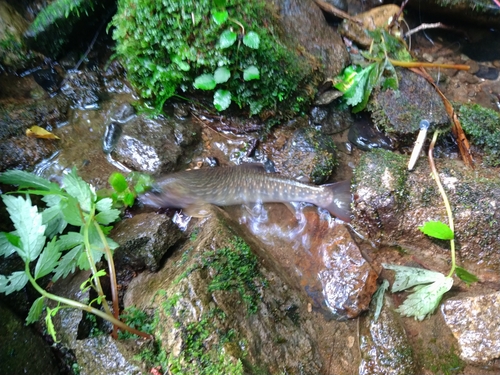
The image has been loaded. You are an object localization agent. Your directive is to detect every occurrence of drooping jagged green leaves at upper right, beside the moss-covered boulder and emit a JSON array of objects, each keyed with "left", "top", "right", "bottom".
[{"left": 334, "top": 29, "right": 411, "bottom": 113}]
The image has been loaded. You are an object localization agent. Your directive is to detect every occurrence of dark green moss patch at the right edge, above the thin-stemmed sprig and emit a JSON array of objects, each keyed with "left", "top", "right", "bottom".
[{"left": 458, "top": 104, "right": 500, "bottom": 167}]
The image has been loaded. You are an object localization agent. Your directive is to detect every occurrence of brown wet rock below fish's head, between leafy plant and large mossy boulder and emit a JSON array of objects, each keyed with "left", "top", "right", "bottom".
[{"left": 111, "top": 213, "right": 182, "bottom": 272}]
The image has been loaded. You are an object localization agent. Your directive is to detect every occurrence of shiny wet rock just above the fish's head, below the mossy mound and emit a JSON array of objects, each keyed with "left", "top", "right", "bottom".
[{"left": 112, "top": 115, "right": 200, "bottom": 173}]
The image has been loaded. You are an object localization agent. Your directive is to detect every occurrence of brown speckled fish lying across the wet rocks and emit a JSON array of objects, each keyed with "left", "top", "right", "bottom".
[{"left": 139, "top": 164, "right": 352, "bottom": 222}]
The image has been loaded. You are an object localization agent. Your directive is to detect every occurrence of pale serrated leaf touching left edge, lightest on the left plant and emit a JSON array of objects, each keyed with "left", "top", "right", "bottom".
[{"left": 2, "top": 195, "right": 45, "bottom": 262}]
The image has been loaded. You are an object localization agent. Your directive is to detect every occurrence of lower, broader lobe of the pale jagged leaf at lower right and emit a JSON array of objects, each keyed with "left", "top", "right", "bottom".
[{"left": 397, "top": 274, "right": 453, "bottom": 320}]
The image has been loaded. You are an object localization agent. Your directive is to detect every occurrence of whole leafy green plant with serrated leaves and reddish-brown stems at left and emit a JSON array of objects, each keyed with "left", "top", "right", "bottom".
[{"left": 0, "top": 169, "right": 149, "bottom": 341}]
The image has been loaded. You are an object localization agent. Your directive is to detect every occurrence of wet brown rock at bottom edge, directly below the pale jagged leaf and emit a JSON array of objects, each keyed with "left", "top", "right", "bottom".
[{"left": 359, "top": 298, "right": 416, "bottom": 375}]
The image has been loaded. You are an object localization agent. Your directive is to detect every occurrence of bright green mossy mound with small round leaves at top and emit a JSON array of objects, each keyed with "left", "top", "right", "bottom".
[{"left": 111, "top": 0, "right": 313, "bottom": 114}]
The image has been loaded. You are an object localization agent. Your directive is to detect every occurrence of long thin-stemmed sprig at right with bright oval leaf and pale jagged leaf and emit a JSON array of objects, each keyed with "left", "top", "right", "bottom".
[{"left": 383, "top": 131, "right": 478, "bottom": 320}]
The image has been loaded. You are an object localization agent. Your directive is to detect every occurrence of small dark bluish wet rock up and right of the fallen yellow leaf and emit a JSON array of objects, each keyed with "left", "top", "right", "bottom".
[{"left": 61, "top": 71, "right": 102, "bottom": 109}]
